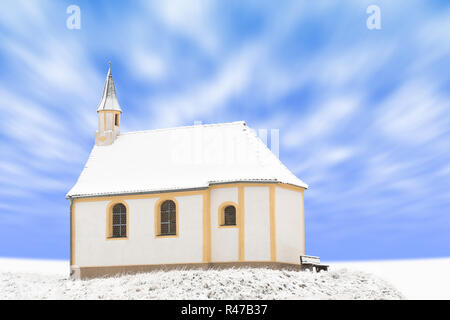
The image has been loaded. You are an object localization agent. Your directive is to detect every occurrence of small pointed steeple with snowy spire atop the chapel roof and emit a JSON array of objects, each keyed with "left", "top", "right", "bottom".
[{"left": 95, "top": 62, "right": 122, "bottom": 146}]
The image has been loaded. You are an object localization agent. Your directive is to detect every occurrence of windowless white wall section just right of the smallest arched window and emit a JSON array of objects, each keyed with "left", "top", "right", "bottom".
[{"left": 244, "top": 186, "right": 270, "bottom": 261}]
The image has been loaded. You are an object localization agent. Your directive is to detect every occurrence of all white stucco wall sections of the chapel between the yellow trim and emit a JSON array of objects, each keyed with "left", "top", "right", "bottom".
[{"left": 74, "top": 186, "right": 304, "bottom": 267}]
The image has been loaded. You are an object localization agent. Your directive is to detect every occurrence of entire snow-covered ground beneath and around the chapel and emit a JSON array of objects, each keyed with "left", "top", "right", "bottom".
[{"left": 0, "top": 258, "right": 450, "bottom": 299}]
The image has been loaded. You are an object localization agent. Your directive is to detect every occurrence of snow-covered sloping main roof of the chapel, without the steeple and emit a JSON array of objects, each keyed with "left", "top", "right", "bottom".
[{"left": 67, "top": 121, "right": 308, "bottom": 197}]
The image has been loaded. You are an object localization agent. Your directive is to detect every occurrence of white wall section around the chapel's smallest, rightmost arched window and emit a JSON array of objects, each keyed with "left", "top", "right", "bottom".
[{"left": 210, "top": 187, "right": 239, "bottom": 262}]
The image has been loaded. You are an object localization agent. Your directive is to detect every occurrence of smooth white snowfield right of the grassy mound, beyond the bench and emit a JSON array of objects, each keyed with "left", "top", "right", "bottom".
[{"left": 328, "top": 258, "right": 450, "bottom": 300}]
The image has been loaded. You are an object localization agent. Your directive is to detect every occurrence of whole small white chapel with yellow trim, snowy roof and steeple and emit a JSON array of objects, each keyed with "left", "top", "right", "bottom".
[{"left": 66, "top": 66, "right": 308, "bottom": 278}]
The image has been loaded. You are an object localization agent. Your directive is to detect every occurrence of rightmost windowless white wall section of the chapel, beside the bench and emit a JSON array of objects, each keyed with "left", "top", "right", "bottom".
[{"left": 275, "top": 187, "right": 304, "bottom": 263}]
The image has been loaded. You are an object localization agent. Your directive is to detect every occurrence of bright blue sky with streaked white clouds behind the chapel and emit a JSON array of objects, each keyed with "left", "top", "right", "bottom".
[{"left": 0, "top": 0, "right": 450, "bottom": 260}]
